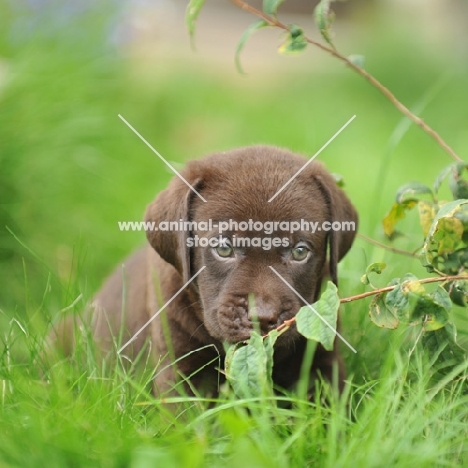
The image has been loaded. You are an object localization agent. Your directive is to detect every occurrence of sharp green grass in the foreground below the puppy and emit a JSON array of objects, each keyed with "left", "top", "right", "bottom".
[{"left": 0, "top": 324, "right": 468, "bottom": 467}]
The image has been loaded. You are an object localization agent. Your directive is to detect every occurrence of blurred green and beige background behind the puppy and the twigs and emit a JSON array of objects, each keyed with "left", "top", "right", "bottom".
[{"left": 0, "top": 0, "right": 468, "bottom": 369}]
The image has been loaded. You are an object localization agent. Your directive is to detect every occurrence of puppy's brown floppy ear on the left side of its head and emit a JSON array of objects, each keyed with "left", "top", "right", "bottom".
[{"left": 145, "top": 177, "right": 203, "bottom": 284}]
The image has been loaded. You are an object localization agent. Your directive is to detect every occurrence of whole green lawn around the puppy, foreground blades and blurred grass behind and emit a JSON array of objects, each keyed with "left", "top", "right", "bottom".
[{"left": 0, "top": 2, "right": 468, "bottom": 468}]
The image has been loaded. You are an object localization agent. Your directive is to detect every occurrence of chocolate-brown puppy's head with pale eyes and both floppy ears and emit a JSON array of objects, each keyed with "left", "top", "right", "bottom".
[{"left": 146, "top": 146, "right": 357, "bottom": 342}]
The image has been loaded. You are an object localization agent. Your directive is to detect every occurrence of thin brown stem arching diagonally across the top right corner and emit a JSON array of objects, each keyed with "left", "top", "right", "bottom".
[{"left": 230, "top": 0, "right": 462, "bottom": 161}]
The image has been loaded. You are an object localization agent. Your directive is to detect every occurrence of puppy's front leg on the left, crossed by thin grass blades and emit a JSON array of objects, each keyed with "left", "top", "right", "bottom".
[{"left": 147, "top": 251, "right": 223, "bottom": 396}]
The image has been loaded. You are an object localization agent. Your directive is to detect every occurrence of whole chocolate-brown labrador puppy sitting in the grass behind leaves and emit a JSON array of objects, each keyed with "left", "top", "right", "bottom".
[{"left": 67, "top": 146, "right": 357, "bottom": 395}]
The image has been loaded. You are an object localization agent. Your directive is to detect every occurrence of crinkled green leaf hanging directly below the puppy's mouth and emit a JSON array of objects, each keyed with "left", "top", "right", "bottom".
[{"left": 225, "top": 332, "right": 270, "bottom": 398}]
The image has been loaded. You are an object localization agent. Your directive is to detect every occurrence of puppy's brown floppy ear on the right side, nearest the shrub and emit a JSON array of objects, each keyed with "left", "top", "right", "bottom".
[{"left": 315, "top": 172, "right": 358, "bottom": 285}]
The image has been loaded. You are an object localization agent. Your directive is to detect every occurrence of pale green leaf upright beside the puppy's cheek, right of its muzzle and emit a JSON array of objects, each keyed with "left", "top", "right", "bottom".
[{"left": 296, "top": 281, "right": 340, "bottom": 351}]
